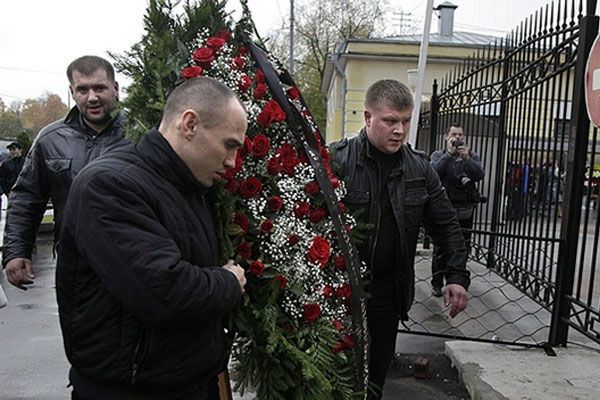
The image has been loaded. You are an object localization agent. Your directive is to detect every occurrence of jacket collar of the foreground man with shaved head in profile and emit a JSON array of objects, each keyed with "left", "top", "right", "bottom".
[{"left": 137, "top": 128, "right": 207, "bottom": 194}]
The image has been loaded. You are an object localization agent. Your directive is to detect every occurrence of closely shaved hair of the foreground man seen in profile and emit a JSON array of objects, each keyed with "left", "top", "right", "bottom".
[{"left": 162, "top": 76, "right": 246, "bottom": 129}]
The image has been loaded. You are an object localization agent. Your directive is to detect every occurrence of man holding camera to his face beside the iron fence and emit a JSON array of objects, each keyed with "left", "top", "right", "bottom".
[{"left": 431, "top": 123, "right": 485, "bottom": 297}]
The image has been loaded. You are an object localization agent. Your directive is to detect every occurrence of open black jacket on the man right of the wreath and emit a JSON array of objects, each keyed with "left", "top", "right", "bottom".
[{"left": 331, "top": 129, "right": 469, "bottom": 320}]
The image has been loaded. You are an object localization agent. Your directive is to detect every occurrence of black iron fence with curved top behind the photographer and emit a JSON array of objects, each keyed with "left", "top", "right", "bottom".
[{"left": 407, "top": 0, "right": 600, "bottom": 345}]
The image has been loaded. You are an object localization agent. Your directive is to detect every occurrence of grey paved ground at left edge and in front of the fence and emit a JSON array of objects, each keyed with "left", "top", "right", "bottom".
[{"left": 0, "top": 235, "right": 600, "bottom": 400}]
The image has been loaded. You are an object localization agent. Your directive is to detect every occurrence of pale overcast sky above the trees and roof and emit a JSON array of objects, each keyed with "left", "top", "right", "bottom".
[{"left": 0, "top": 0, "right": 568, "bottom": 104}]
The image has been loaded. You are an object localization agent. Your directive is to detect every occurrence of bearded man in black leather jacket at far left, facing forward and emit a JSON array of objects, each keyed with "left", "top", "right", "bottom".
[{"left": 2, "top": 56, "right": 128, "bottom": 290}]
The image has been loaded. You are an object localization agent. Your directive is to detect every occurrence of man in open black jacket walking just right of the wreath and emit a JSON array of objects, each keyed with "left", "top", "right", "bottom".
[{"left": 332, "top": 79, "right": 469, "bottom": 399}]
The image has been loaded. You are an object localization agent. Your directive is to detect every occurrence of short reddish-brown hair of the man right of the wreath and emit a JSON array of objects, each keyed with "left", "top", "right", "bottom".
[{"left": 365, "top": 79, "right": 414, "bottom": 111}]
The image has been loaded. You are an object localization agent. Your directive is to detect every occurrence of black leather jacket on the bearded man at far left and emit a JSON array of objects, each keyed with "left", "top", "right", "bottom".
[{"left": 2, "top": 107, "right": 127, "bottom": 265}]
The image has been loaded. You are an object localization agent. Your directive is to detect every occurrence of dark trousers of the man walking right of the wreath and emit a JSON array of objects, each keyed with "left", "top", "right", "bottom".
[{"left": 367, "top": 295, "right": 399, "bottom": 400}]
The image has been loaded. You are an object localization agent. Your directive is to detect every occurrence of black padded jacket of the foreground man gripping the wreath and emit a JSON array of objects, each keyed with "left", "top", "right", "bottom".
[{"left": 56, "top": 130, "right": 241, "bottom": 399}]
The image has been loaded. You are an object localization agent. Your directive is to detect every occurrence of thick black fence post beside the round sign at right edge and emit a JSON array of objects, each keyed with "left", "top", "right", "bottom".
[{"left": 548, "top": 0, "right": 599, "bottom": 346}]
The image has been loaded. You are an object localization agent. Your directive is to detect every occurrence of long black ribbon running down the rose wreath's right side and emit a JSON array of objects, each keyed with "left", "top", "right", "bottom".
[{"left": 243, "top": 34, "right": 369, "bottom": 396}]
